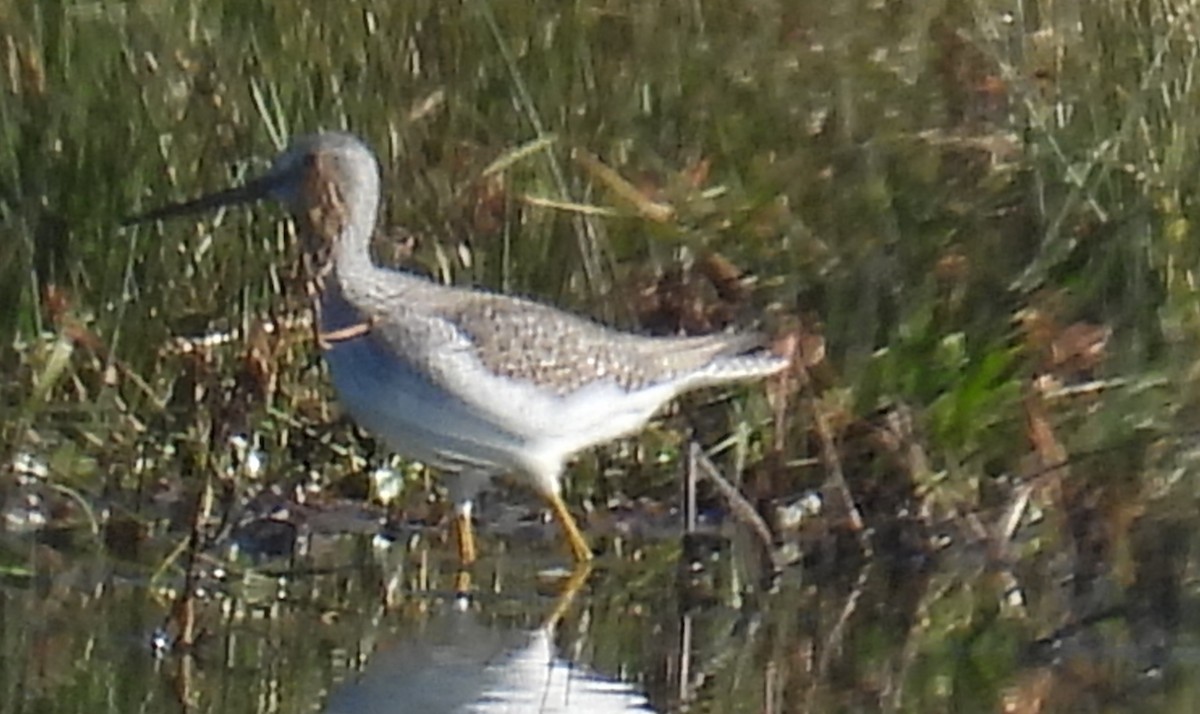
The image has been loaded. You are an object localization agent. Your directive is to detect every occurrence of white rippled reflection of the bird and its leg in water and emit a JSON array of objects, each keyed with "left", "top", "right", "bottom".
[{"left": 325, "top": 572, "right": 653, "bottom": 714}]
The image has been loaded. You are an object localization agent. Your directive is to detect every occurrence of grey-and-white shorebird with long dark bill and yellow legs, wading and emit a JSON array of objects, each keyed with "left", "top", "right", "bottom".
[{"left": 127, "top": 132, "right": 787, "bottom": 564}]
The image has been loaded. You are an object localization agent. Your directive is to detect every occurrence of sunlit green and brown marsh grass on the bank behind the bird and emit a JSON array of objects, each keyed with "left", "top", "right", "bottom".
[{"left": 0, "top": 0, "right": 1200, "bottom": 710}]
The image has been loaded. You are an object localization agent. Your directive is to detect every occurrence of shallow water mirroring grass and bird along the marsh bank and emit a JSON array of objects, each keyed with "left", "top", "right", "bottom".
[{"left": 0, "top": 504, "right": 1200, "bottom": 712}]
